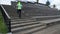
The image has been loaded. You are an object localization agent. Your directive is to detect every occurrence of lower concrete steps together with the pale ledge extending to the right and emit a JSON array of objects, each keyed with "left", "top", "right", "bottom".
[{"left": 11, "top": 18, "right": 60, "bottom": 34}]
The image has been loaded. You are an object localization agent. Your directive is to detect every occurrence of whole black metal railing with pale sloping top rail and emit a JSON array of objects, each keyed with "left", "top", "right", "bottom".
[{"left": 0, "top": 5, "right": 11, "bottom": 33}]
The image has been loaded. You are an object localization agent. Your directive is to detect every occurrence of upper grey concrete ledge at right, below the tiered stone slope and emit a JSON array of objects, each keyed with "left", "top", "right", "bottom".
[{"left": 32, "top": 15, "right": 60, "bottom": 21}]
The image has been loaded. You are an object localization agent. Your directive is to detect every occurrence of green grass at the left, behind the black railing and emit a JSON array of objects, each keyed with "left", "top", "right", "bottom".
[{"left": 0, "top": 10, "right": 7, "bottom": 34}]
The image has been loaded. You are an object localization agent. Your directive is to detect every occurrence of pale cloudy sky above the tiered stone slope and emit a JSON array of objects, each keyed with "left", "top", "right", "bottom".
[{"left": 0, "top": 0, "right": 60, "bottom": 9}]
